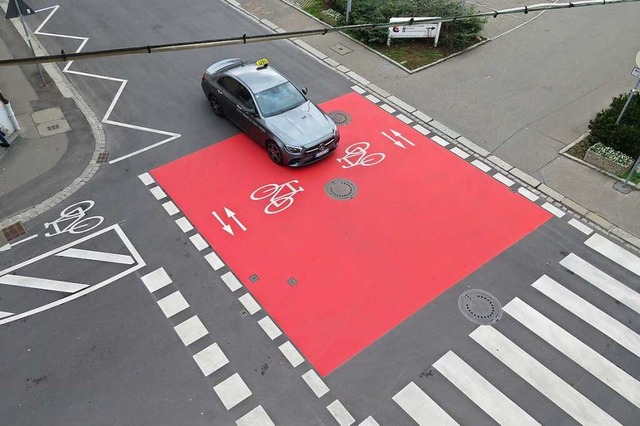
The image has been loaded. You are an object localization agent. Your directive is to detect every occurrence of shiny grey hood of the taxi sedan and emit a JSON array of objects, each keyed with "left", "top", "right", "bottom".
[{"left": 266, "top": 101, "right": 335, "bottom": 146}]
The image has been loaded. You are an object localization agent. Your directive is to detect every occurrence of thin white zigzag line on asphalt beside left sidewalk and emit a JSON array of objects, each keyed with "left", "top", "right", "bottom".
[{"left": 33, "top": 5, "right": 182, "bottom": 164}]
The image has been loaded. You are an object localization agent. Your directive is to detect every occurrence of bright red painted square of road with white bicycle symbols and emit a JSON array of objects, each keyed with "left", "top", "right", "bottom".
[{"left": 152, "top": 93, "right": 550, "bottom": 376}]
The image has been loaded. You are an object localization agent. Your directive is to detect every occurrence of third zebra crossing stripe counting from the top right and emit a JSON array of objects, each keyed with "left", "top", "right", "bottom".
[{"left": 533, "top": 275, "right": 640, "bottom": 356}]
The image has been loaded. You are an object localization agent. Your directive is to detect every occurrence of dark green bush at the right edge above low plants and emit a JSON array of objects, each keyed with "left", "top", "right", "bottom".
[{"left": 589, "top": 94, "right": 640, "bottom": 158}]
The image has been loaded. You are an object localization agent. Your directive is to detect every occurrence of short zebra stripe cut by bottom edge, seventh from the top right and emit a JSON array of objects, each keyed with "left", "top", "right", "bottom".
[{"left": 393, "top": 382, "right": 458, "bottom": 426}]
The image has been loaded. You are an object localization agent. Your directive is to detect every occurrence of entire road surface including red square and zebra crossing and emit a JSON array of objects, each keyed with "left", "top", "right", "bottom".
[{"left": 0, "top": 0, "right": 640, "bottom": 426}]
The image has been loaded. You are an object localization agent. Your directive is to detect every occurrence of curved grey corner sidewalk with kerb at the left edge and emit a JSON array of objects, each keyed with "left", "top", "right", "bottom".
[{"left": 0, "top": 12, "right": 104, "bottom": 240}]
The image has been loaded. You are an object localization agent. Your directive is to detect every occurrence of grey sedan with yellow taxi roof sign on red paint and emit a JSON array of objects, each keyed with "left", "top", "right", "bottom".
[{"left": 202, "top": 58, "right": 340, "bottom": 167}]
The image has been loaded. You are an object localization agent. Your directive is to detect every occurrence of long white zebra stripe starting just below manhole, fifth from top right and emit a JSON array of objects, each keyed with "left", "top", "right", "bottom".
[{"left": 469, "top": 325, "right": 620, "bottom": 426}]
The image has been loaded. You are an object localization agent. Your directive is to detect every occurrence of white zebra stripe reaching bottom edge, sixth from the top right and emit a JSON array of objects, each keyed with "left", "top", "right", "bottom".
[{"left": 433, "top": 351, "right": 540, "bottom": 426}]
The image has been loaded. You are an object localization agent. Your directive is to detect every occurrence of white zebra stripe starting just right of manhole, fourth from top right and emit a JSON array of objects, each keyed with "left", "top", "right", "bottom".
[{"left": 503, "top": 297, "right": 640, "bottom": 407}]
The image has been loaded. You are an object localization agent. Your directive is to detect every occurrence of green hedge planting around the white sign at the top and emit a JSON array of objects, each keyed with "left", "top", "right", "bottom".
[{"left": 325, "top": 0, "right": 485, "bottom": 50}]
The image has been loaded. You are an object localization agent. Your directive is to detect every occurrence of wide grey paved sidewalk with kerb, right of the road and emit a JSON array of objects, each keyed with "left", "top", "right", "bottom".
[{"left": 227, "top": 0, "right": 640, "bottom": 248}]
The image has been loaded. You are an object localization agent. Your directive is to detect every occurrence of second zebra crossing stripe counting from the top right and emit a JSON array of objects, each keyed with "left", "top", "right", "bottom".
[{"left": 560, "top": 253, "right": 640, "bottom": 314}]
